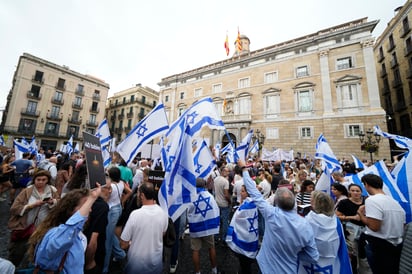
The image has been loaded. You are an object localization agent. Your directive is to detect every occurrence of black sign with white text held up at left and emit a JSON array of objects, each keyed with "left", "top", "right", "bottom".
[{"left": 83, "top": 132, "right": 106, "bottom": 189}]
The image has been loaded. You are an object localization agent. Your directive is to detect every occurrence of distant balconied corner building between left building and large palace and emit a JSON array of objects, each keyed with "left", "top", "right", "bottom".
[{"left": 106, "top": 84, "right": 159, "bottom": 141}]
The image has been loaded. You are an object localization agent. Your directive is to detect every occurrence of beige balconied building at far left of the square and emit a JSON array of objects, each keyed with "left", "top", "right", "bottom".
[{"left": 0, "top": 53, "right": 109, "bottom": 150}]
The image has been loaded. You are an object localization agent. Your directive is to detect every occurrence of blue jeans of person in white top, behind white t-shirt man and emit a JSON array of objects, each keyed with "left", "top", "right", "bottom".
[{"left": 103, "top": 204, "right": 126, "bottom": 273}]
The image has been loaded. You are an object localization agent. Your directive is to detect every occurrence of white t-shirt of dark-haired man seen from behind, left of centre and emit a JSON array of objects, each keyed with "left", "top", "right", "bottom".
[{"left": 120, "top": 205, "right": 169, "bottom": 273}]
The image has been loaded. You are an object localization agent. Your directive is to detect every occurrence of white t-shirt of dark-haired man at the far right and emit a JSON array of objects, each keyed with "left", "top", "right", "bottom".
[{"left": 365, "top": 194, "right": 405, "bottom": 244}]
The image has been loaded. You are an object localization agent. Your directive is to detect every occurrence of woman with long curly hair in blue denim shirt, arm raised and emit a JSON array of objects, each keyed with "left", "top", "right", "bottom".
[{"left": 29, "top": 184, "right": 101, "bottom": 273}]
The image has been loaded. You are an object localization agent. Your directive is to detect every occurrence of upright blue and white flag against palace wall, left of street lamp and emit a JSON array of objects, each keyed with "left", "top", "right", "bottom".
[{"left": 315, "top": 134, "right": 342, "bottom": 195}]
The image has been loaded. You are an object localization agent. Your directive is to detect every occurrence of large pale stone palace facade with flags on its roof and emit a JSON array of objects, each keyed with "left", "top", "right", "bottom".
[{"left": 159, "top": 18, "right": 390, "bottom": 159}]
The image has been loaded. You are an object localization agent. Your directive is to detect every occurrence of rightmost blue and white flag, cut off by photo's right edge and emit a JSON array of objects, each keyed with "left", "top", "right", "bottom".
[{"left": 374, "top": 126, "right": 412, "bottom": 223}]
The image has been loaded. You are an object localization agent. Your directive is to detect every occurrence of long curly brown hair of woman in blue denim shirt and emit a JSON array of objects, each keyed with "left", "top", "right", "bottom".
[{"left": 28, "top": 188, "right": 89, "bottom": 262}]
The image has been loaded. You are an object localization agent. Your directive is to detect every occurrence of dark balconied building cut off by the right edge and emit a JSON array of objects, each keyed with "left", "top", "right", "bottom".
[{"left": 374, "top": 1, "right": 412, "bottom": 141}]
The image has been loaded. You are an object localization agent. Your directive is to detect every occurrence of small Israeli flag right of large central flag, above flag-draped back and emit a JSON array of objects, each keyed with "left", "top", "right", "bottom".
[{"left": 193, "top": 140, "right": 216, "bottom": 179}]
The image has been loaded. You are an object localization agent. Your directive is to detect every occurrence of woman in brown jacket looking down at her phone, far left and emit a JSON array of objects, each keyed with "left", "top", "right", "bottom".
[{"left": 8, "top": 170, "right": 58, "bottom": 267}]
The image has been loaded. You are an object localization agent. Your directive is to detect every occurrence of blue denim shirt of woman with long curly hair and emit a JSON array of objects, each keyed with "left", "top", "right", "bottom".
[{"left": 35, "top": 211, "right": 87, "bottom": 273}]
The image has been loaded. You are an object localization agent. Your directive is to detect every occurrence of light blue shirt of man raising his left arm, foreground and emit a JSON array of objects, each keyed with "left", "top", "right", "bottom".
[{"left": 243, "top": 171, "right": 319, "bottom": 274}]
